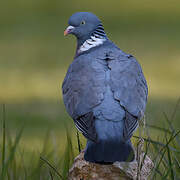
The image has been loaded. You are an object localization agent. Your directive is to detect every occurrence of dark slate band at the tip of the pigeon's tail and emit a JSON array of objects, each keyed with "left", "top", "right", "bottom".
[{"left": 84, "top": 140, "right": 135, "bottom": 164}]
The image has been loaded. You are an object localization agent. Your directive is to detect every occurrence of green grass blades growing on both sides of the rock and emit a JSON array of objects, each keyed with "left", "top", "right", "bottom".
[{"left": 0, "top": 101, "right": 180, "bottom": 180}]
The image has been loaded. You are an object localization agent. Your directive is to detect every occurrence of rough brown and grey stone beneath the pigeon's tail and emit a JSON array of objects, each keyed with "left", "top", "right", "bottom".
[{"left": 68, "top": 152, "right": 154, "bottom": 180}]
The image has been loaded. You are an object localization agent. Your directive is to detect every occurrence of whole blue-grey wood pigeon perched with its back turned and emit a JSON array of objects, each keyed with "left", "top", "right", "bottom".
[{"left": 62, "top": 12, "right": 148, "bottom": 164}]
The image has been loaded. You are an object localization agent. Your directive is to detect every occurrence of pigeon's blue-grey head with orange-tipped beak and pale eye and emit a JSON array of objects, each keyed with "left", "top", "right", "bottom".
[{"left": 64, "top": 12, "right": 106, "bottom": 43}]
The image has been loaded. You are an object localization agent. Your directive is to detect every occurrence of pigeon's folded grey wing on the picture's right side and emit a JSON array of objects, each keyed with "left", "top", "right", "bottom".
[{"left": 109, "top": 54, "right": 148, "bottom": 139}]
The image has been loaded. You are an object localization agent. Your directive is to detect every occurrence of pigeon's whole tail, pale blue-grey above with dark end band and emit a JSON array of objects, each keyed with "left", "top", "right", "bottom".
[{"left": 84, "top": 119, "right": 135, "bottom": 164}]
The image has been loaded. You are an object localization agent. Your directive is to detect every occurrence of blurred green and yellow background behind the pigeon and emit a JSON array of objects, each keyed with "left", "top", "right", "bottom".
[{"left": 0, "top": 0, "right": 180, "bottom": 158}]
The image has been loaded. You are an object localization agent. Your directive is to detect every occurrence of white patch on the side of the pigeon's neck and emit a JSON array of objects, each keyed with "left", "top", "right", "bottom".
[{"left": 78, "top": 36, "right": 106, "bottom": 53}]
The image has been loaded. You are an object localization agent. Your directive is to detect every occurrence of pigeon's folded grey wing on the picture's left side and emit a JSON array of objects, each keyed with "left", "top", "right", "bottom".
[{"left": 62, "top": 55, "right": 105, "bottom": 141}]
